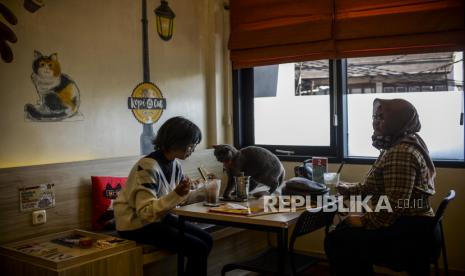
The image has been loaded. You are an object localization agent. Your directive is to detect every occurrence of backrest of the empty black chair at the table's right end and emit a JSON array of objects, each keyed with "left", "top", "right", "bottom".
[{"left": 289, "top": 203, "right": 337, "bottom": 252}]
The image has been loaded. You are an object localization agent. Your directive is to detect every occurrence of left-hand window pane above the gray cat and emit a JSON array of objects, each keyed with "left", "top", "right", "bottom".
[{"left": 234, "top": 60, "right": 335, "bottom": 156}]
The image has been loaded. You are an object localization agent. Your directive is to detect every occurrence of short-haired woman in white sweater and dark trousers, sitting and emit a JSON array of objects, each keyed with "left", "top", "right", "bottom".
[{"left": 113, "top": 117, "right": 213, "bottom": 275}]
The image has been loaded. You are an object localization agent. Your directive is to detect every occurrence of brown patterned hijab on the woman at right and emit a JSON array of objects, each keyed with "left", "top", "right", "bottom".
[{"left": 371, "top": 99, "right": 436, "bottom": 180}]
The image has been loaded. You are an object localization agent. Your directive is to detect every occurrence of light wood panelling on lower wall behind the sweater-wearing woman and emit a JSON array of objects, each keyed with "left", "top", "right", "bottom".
[{"left": 0, "top": 149, "right": 222, "bottom": 244}]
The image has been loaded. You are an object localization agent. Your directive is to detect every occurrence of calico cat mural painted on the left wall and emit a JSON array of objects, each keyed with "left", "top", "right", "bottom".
[{"left": 24, "top": 51, "right": 82, "bottom": 122}]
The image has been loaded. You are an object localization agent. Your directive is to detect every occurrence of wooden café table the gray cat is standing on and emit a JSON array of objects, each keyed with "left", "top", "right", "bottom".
[{"left": 172, "top": 200, "right": 304, "bottom": 275}]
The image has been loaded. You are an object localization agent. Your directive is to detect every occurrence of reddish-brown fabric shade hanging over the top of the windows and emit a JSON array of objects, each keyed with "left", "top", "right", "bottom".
[{"left": 229, "top": 0, "right": 465, "bottom": 68}]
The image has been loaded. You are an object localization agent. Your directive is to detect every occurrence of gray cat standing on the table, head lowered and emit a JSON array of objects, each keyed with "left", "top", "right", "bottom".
[{"left": 213, "top": 145, "right": 285, "bottom": 198}]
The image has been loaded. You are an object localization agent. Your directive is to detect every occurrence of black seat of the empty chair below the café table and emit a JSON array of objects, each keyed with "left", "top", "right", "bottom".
[{"left": 222, "top": 248, "right": 318, "bottom": 275}]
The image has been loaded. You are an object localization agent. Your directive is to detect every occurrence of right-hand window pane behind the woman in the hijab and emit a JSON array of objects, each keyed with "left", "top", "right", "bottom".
[{"left": 347, "top": 52, "right": 464, "bottom": 160}]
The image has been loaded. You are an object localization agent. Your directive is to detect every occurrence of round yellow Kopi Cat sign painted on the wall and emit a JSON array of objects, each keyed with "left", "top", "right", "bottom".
[{"left": 128, "top": 82, "right": 166, "bottom": 124}]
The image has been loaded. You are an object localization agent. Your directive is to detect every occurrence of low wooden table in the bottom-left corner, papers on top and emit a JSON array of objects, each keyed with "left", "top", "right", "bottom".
[{"left": 0, "top": 229, "right": 143, "bottom": 276}]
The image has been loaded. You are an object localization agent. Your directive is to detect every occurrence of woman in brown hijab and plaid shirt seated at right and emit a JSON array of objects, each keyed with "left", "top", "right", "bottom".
[{"left": 325, "top": 99, "right": 436, "bottom": 275}]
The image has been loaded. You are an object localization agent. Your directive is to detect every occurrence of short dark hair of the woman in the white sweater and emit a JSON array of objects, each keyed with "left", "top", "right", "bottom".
[{"left": 153, "top": 117, "right": 202, "bottom": 150}]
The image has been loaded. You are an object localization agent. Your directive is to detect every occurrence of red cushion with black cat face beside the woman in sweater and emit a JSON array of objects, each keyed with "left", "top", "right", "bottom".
[{"left": 91, "top": 176, "right": 127, "bottom": 230}]
